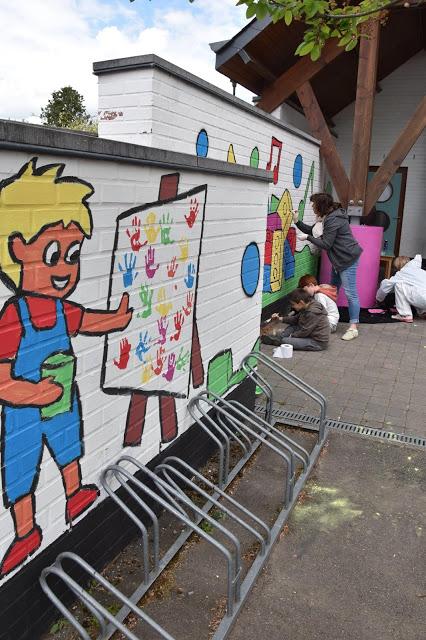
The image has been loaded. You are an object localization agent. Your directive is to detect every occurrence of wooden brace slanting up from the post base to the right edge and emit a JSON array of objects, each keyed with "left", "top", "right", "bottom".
[{"left": 364, "top": 97, "right": 426, "bottom": 215}]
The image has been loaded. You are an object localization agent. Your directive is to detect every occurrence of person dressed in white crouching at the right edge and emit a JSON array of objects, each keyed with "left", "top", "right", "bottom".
[{"left": 376, "top": 254, "right": 426, "bottom": 322}]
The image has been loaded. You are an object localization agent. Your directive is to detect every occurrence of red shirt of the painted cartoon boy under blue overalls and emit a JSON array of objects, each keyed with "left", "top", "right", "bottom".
[{"left": 0, "top": 295, "right": 84, "bottom": 362}]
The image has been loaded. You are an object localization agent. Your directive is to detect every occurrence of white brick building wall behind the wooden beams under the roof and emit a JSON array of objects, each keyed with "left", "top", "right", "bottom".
[{"left": 334, "top": 51, "right": 426, "bottom": 256}]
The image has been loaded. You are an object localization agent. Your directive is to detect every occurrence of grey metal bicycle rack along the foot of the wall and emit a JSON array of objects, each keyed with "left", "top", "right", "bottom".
[{"left": 40, "top": 352, "right": 327, "bottom": 640}]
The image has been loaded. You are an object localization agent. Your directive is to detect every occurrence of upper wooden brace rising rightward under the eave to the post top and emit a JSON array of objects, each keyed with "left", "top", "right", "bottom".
[{"left": 257, "top": 38, "right": 345, "bottom": 113}]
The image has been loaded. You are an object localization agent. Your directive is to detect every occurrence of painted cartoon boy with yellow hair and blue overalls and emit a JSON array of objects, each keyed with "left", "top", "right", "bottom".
[{"left": 0, "top": 158, "right": 132, "bottom": 578}]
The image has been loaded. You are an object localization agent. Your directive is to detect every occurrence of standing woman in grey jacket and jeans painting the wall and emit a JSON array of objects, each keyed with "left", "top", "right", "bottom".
[{"left": 293, "top": 193, "right": 362, "bottom": 340}]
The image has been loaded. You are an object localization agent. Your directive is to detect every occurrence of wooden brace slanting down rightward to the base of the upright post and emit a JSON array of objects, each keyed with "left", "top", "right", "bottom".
[{"left": 297, "top": 82, "right": 349, "bottom": 206}]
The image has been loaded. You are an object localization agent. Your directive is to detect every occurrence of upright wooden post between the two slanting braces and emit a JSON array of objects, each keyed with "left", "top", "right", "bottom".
[{"left": 349, "top": 20, "right": 380, "bottom": 210}]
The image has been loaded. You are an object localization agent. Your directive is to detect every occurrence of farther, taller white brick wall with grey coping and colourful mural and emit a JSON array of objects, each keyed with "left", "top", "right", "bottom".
[{"left": 95, "top": 56, "right": 322, "bottom": 307}]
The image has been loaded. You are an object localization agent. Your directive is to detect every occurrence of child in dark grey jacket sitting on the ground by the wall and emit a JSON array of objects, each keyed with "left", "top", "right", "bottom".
[{"left": 262, "top": 289, "right": 330, "bottom": 351}]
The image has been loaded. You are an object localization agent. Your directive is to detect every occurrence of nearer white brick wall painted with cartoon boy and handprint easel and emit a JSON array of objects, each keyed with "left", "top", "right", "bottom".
[{"left": 0, "top": 122, "right": 269, "bottom": 640}]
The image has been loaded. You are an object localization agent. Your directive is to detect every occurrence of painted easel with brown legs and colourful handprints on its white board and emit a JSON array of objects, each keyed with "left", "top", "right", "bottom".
[{"left": 101, "top": 174, "right": 207, "bottom": 446}]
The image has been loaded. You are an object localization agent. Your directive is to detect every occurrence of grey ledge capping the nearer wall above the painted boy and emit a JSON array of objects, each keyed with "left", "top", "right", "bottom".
[{"left": 0, "top": 120, "right": 272, "bottom": 182}]
